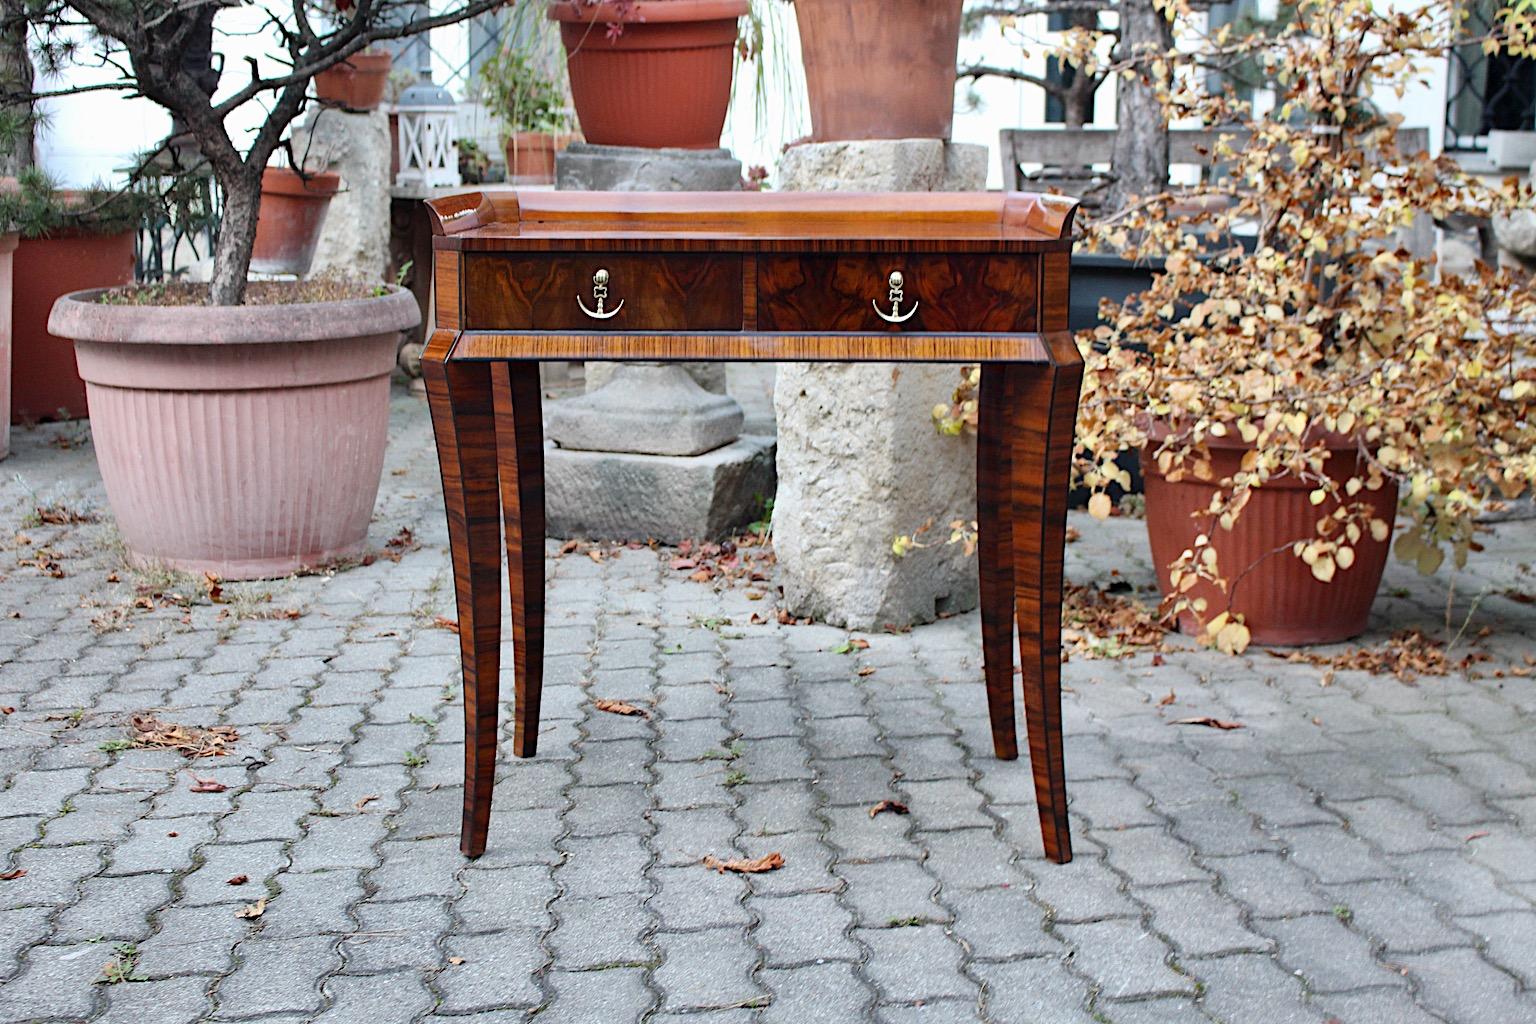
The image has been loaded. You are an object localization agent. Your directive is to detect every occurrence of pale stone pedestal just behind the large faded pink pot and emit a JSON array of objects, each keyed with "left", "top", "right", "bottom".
[{"left": 293, "top": 107, "right": 390, "bottom": 281}]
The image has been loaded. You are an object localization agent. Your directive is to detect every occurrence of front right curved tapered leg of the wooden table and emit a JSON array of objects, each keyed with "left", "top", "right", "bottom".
[{"left": 1014, "top": 335, "right": 1083, "bottom": 864}]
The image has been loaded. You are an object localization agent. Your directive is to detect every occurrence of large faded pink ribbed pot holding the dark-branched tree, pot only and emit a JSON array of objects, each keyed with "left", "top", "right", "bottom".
[{"left": 49, "top": 289, "right": 421, "bottom": 579}]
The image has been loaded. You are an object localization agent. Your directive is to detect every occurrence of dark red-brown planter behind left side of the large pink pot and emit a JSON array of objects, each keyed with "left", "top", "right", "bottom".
[{"left": 8, "top": 230, "right": 135, "bottom": 424}]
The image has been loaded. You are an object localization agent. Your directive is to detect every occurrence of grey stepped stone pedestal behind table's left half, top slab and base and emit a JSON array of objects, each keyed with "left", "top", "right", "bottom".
[{"left": 544, "top": 143, "right": 774, "bottom": 543}]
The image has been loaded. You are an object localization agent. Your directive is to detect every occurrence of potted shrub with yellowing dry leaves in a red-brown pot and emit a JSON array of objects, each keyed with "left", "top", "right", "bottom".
[{"left": 1077, "top": 0, "right": 1536, "bottom": 649}]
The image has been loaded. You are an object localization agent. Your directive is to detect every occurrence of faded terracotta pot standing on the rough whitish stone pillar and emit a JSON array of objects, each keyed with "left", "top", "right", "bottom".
[{"left": 794, "top": 0, "right": 963, "bottom": 143}]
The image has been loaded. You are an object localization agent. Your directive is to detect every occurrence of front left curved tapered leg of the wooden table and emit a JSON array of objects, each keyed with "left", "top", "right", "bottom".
[{"left": 421, "top": 336, "right": 501, "bottom": 857}]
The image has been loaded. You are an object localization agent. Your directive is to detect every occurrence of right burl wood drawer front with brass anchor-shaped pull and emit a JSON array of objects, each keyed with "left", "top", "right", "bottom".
[{"left": 757, "top": 253, "right": 1040, "bottom": 332}]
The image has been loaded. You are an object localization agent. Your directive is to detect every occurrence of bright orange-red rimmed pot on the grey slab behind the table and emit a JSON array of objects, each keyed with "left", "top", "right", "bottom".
[{"left": 548, "top": 0, "right": 746, "bottom": 149}]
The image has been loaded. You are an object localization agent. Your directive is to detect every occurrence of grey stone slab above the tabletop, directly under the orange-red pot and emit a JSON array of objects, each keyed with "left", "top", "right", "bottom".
[{"left": 554, "top": 143, "right": 742, "bottom": 192}]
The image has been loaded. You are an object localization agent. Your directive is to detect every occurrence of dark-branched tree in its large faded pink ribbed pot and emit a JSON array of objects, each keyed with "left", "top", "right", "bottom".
[{"left": 29, "top": 0, "right": 501, "bottom": 579}]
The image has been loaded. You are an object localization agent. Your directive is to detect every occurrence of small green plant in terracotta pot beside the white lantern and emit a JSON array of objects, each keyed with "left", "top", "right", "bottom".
[{"left": 475, "top": 46, "right": 570, "bottom": 184}]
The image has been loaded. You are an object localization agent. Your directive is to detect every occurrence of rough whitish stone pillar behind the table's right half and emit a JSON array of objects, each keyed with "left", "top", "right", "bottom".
[{"left": 773, "top": 138, "right": 986, "bottom": 629}]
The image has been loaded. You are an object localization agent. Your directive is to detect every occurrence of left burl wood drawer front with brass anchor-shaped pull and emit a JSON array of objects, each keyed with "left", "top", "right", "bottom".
[{"left": 464, "top": 253, "right": 742, "bottom": 332}]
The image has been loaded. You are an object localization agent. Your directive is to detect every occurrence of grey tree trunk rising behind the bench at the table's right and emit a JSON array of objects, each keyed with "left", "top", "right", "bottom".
[{"left": 1104, "top": 0, "right": 1174, "bottom": 213}]
